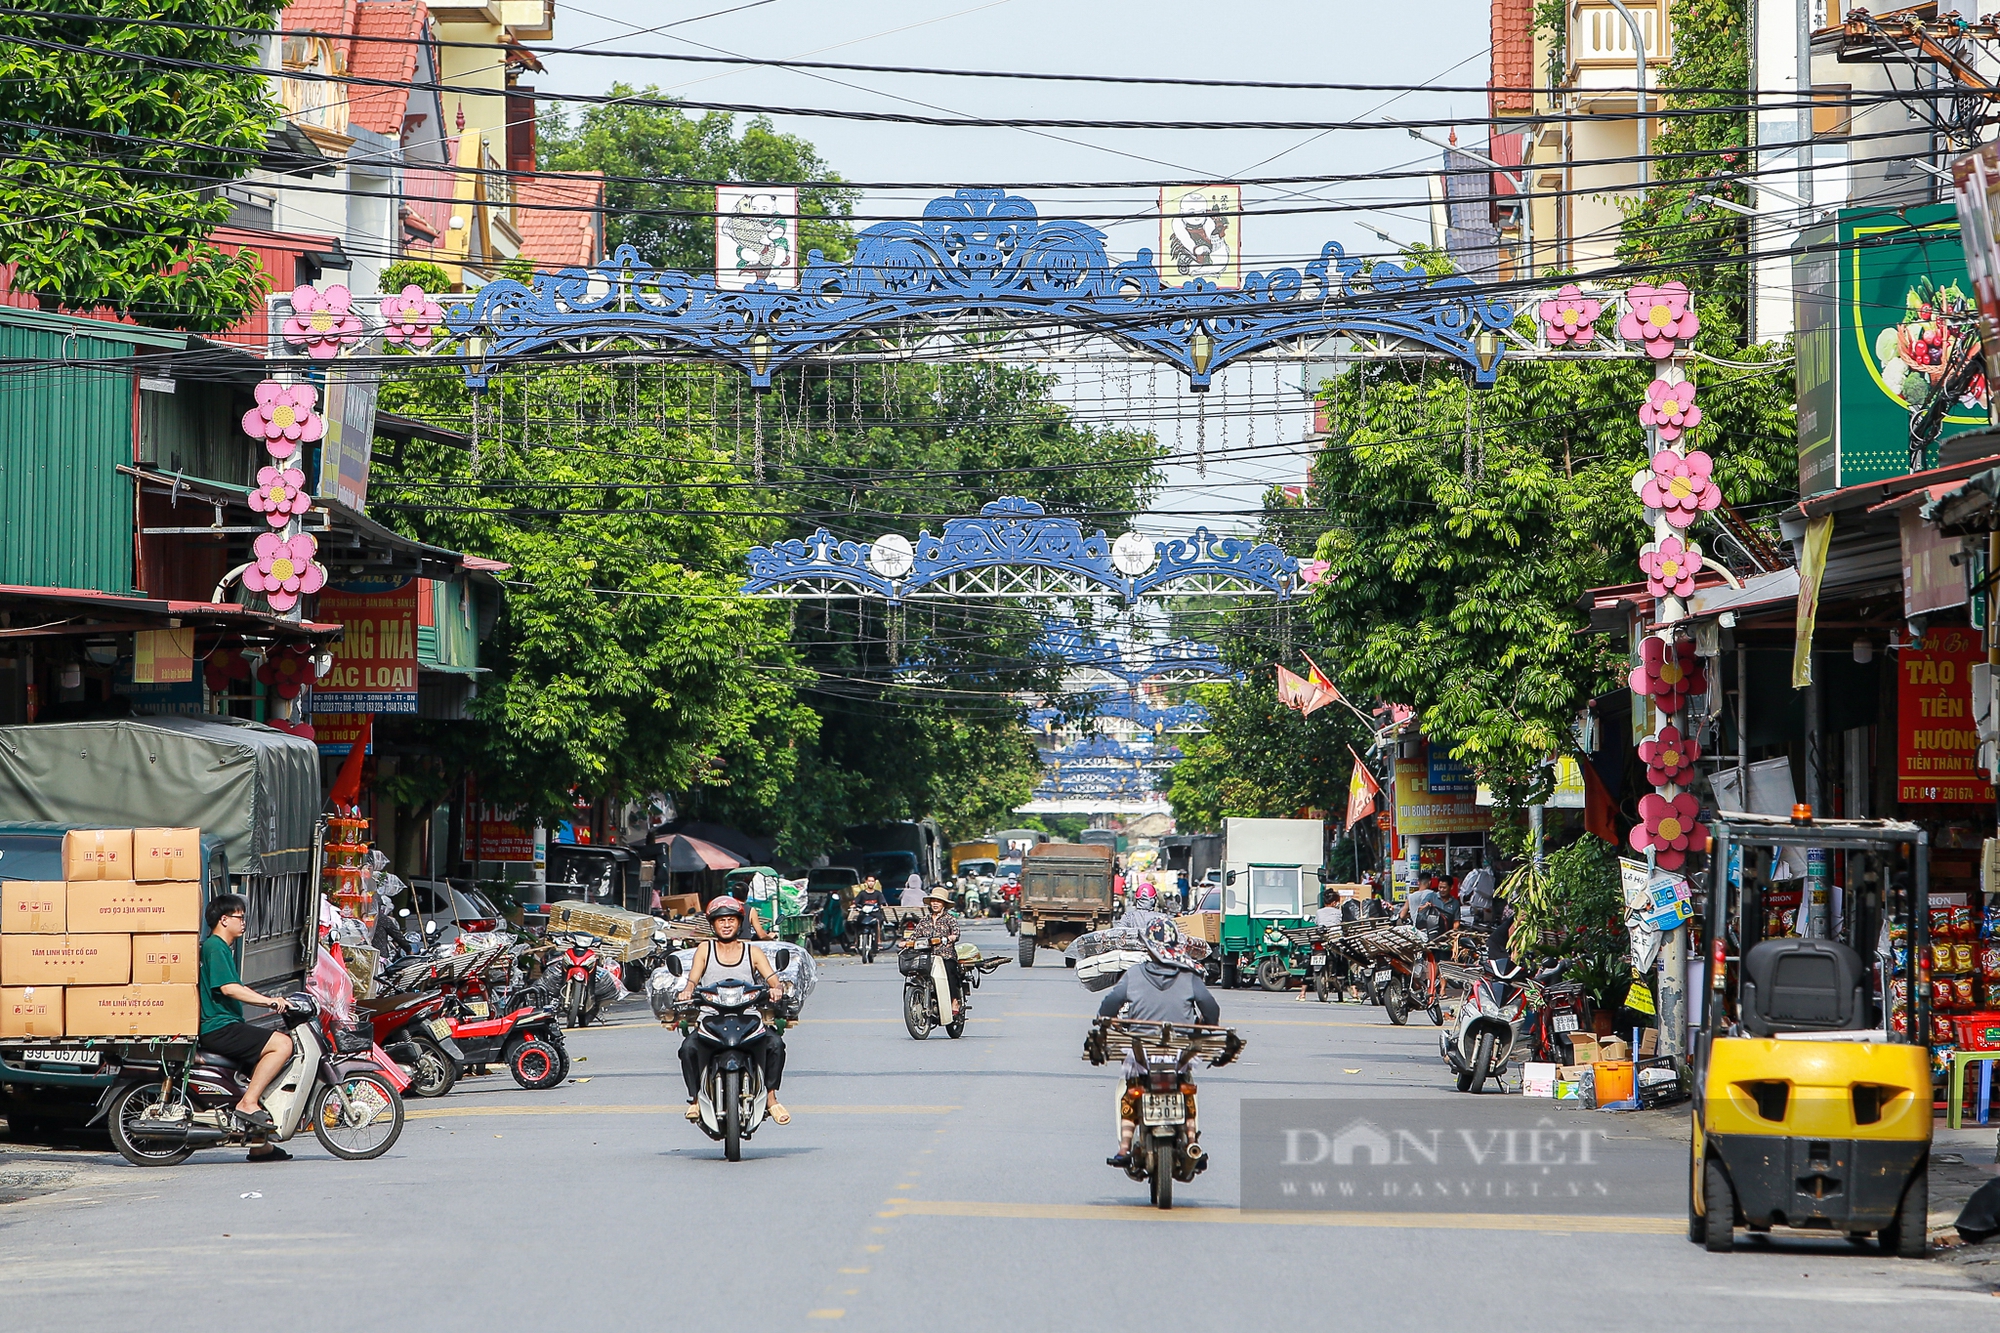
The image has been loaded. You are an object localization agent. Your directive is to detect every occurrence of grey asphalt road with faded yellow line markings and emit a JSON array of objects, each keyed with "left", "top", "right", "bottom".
[{"left": 0, "top": 912, "right": 2000, "bottom": 1333}]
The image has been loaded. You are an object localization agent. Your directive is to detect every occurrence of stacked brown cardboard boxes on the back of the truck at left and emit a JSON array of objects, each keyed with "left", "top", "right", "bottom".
[{"left": 0, "top": 829, "right": 202, "bottom": 1037}]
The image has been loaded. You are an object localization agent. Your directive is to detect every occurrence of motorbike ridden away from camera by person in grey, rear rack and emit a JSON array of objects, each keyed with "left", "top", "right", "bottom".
[{"left": 1084, "top": 1019, "right": 1244, "bottom": 1211}]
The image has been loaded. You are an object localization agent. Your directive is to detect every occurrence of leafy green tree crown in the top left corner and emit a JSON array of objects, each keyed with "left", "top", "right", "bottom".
[{"left": 0, "top": 0, "right": 284, "bottom": 332}]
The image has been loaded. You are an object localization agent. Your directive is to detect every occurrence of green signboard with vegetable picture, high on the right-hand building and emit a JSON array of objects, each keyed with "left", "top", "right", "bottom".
[{"left": 1792, "top": 204, "right": 1986, "bottom": 496}]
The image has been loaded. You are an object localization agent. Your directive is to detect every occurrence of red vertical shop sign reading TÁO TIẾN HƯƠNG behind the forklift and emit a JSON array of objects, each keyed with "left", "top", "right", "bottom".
[{"left": 1896, "top": 626, "right": 1994, "bottom": 805}]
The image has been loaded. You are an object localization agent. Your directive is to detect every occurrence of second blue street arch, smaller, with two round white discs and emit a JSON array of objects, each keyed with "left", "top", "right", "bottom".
[{"left": 742, "top": 496, "right": 1298, "bottom": 602}]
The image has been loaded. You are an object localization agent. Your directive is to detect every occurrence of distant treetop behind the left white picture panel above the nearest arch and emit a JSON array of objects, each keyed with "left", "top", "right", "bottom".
[{"left": 536, "top": 84, "right": 856, "bottom": 272}]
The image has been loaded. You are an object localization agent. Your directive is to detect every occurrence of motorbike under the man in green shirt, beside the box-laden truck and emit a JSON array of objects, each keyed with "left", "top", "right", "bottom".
[{"left": 100, "top": 993, "right": 404, "bottom": 1167}]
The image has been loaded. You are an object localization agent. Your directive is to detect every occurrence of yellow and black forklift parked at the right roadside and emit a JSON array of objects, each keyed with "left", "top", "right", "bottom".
[{"left": 1688, "top": 807, "right": 1932, "bottom": 1259}]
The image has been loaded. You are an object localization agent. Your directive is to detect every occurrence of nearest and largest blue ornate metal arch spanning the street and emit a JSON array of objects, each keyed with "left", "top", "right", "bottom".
[{"left": 444, "top": 190, "right": 1514, "bottom": 392}]
